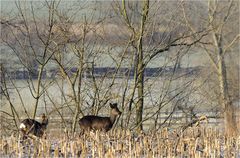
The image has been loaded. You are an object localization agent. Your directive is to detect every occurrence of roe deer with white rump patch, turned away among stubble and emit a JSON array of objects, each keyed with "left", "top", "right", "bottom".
[{"left": 20, "top": 114, "right": 48, "bottom": 138}]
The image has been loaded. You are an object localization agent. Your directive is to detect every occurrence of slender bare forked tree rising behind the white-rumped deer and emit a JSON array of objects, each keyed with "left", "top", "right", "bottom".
[{"left": 1, "top": 1, "right": 57, "bottom": 118}]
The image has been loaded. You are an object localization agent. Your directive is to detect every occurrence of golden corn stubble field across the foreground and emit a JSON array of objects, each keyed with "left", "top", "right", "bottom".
[{"left": 0, "top": 127, "right": 240, "bottom": 158}]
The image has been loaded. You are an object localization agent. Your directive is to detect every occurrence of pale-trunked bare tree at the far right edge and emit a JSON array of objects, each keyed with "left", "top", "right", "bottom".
[{"left": 183, "top": 1, "right": 240, "bottom": 136}]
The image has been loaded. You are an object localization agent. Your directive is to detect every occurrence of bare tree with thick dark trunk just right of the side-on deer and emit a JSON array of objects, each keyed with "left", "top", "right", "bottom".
[{"left": 116, "top": 0, "right": 206, "bottom": 131}]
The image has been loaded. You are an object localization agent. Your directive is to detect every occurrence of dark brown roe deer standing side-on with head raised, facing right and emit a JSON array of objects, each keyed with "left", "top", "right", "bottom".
[{"left": 79, "top": 103, "right": 122, "bottom": 133}]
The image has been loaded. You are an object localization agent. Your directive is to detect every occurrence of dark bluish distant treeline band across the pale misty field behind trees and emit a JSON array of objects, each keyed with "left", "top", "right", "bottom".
[{"left": 1, "top": 67, "right": 200, "bottom": 79}]
